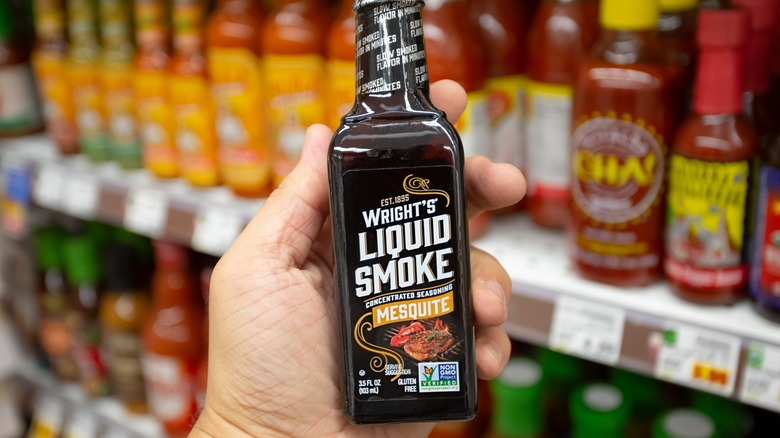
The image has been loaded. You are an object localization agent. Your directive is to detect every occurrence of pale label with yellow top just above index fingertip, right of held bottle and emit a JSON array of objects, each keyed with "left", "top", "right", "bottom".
[{"left": 455, "top": 90, "right": 493, "bottom": 157}]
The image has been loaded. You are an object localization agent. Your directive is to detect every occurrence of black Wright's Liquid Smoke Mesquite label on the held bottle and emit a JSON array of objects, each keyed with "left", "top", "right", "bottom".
[{"left": 341, "top": 166, "right": 472, "bottom": 400}]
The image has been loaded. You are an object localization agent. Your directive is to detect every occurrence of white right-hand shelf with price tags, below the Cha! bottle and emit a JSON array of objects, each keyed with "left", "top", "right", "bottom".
[{"left": 476, "top": 216, "right": 780, "bottom": 412}]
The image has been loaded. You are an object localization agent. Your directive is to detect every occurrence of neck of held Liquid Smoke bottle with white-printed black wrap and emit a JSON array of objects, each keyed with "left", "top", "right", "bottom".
[{"left": 355, "top": 0, "right": 431, "bottom": 112}]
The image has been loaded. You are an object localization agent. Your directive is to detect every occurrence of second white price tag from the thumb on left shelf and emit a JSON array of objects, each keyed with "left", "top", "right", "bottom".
[{"left": 125, "top": 188, "right": 168, "bottom": 237}]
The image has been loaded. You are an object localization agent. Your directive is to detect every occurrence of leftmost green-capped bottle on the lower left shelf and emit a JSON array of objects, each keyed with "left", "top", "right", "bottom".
[{"left": 33, "top": 227, "right": 79, "bottom": 380}]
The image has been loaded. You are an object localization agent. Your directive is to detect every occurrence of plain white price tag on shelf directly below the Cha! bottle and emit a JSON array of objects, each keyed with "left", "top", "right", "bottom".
[{"left": 549, "top": 296, "right": 626, "bottom": 365}]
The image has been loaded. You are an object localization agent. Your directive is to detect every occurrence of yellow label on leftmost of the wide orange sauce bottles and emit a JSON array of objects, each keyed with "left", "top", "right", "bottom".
[{"left": 208, "top": 49, "right": 272, "bottom": 190}]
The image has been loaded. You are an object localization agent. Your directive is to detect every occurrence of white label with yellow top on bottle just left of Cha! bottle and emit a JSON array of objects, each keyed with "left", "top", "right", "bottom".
[{"left": 526, "top": 81, "right": 572, "bottom": 199}]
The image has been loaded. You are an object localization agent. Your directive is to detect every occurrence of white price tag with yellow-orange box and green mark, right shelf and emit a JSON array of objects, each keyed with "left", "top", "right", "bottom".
[{"left": 655, "top": 322, "right": 740, "bottom": 397}]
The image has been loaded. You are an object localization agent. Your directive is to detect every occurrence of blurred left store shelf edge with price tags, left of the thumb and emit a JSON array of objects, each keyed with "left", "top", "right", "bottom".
[{"left": 0, "top": 135, "right": 263, "bottom": 255}]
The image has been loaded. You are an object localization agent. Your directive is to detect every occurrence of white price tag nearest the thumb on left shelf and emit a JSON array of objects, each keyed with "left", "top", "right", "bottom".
[{"left": 191, "top": 207, "right": 245, "bottom": 256}]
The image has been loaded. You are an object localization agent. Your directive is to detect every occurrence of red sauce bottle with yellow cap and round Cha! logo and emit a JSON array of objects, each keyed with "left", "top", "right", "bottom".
[{"left": 568, "top": 0, "right": 671, "bottom": 286}]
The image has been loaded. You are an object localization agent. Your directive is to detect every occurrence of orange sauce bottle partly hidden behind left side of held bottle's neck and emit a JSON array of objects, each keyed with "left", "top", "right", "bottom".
[{"left": 326, "top": 0, "right": 355, "bottom": 129}]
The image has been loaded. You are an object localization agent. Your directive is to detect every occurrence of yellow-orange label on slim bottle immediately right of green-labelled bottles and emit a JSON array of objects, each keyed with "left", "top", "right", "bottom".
[{"left": 133, "top": 70, "right": 178, "bottom": 177}]
